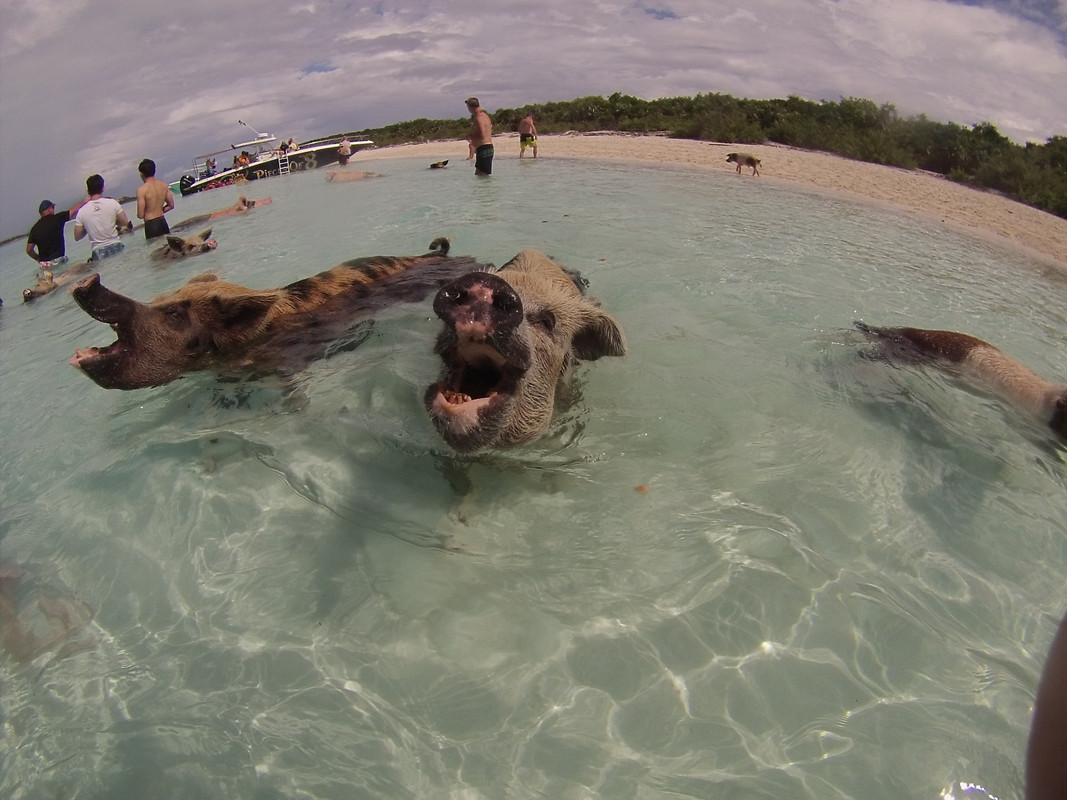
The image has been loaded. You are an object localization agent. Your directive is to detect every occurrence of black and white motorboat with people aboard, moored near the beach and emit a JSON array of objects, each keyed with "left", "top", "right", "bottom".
[{"left": 172, "top": 119, "right": 375, "bottom": 195}]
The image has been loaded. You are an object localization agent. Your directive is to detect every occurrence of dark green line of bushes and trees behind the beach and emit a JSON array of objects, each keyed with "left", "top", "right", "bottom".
[{"left": 349, "top": 92, "right": 1067, "bottom": 219}]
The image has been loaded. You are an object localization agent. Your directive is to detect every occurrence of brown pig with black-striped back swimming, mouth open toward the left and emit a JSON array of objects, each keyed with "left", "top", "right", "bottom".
[{"left": 70, "top": 238, "right": 483, "bottom": 389}]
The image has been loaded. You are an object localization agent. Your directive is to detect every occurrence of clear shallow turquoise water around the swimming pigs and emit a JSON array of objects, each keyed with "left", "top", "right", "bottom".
[{"left": 0, "top": 158, "right": 1067, "bottom": 800}]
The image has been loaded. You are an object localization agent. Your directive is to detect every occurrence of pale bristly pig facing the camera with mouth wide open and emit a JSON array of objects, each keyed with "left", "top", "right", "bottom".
[{"left": 425, "top": 250, "right": 626, "bottom": 452}]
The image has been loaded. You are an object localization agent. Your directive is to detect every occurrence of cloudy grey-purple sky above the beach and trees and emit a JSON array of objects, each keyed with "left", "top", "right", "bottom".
[{"left": 0, "top": 0, "right": 1067, "bottom": 237}]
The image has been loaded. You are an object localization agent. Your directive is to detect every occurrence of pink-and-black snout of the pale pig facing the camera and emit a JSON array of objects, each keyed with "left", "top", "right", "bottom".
[{"left": 433, "top": 272, "right": 523, "bottom": 341}]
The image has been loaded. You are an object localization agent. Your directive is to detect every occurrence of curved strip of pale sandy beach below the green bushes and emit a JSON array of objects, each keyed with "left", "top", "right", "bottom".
[{"left": 352, "top": 133, "right": 1067, "bottom": 272}]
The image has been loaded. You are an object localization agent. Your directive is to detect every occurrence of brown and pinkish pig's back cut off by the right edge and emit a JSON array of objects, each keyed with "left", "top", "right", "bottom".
[{"left": 854, "top": 322, "right": 1067, "bottom": 441}]
